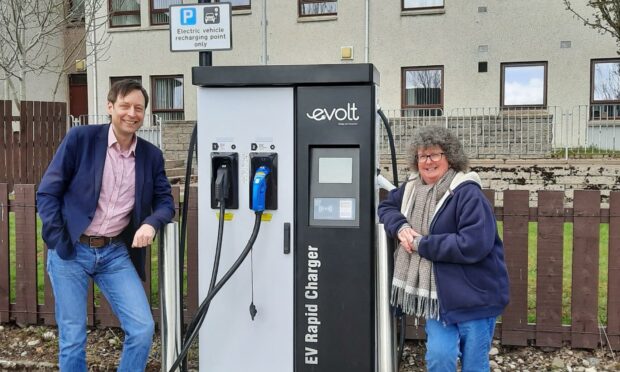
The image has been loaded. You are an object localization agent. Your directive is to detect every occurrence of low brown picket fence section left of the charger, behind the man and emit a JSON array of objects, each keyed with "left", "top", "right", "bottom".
[{"left": 0, "top": 183, "right": 198, "bottom": 327}]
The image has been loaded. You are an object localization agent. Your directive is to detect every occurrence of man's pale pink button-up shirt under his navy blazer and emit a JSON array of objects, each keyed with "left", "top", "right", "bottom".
[{"left": 84, "top": 125, "right": 137, "bottom": 237}]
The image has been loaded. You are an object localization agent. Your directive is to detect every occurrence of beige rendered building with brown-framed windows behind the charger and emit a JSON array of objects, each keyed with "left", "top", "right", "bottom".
[{"left": 83, "top": 0, "right": 620, "bottom": 121}]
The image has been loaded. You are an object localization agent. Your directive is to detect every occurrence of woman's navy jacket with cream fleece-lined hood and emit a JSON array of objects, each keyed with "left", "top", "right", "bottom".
[{"left": 378, "top": 172, "right": 509, "bottom": 324}]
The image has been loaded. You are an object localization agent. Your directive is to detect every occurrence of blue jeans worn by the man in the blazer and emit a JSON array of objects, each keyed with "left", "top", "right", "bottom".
[{"left": 47, "top": 242, "right": 154, "bottom": 372}]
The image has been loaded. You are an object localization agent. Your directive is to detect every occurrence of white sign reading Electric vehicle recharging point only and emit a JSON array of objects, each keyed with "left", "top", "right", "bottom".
[{"left": 170, "top": 3, "right": 232, "bottom": 52}]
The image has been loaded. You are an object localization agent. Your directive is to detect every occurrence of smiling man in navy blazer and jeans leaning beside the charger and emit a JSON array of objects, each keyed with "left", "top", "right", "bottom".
[{"left": 37, "top": 80, "right": 174, "bottom": 372}]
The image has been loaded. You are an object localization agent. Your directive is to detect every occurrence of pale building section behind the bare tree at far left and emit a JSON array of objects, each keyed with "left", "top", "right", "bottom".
[{"left": 0, "top": 0, "right": 89, "bottom": 115}]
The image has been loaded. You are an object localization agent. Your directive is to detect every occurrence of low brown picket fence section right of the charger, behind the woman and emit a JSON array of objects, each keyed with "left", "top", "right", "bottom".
[{"left": 407, "top": 190, "right": 620, "bottom": 350}]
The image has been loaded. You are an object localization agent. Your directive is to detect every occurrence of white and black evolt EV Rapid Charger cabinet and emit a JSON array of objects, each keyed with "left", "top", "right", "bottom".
[{"left": 193, "top": 64, "right": 392, "bottom": 372}]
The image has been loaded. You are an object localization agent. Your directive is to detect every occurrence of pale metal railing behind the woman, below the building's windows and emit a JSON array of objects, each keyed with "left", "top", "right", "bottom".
[{"left": 379, "top": 104, "right": 620, "bottom": 158}]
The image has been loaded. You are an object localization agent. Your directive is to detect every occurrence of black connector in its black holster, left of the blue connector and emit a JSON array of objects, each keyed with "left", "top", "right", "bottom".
[{"left": 211, "top": 152, "right": 239, "bottom": 209}]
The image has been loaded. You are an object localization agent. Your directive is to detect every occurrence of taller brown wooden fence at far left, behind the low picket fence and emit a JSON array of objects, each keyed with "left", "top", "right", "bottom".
[{"left": 0, "top": 100, "right": 67, "bottom": 190}]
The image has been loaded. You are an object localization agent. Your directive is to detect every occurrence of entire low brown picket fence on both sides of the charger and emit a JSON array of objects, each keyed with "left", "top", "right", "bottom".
[{"left": 0, "top": 184, "right": 620, "bottom": 350}]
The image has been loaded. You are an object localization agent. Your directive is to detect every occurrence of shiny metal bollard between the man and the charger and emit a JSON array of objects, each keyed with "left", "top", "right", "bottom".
[{"left": 158, "top": 221, "right": 183, "bottom": 372}]
